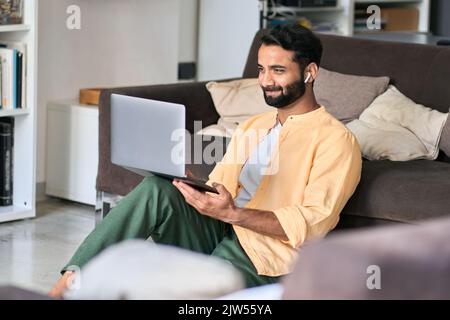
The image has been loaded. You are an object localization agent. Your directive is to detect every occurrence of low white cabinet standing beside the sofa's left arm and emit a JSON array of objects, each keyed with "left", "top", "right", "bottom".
[{"left": 46, "top": 101, "right": 98, "bottom": 205}]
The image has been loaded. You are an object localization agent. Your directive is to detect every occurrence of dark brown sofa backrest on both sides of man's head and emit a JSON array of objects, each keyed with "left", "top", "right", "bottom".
[{"left": 243, "top": 30, "right": 450, "bottom": 112}]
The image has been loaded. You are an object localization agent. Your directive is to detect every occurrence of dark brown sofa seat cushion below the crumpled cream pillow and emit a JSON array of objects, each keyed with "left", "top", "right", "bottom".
[{"left": 342, "top": 160, "right": 450, "bottom": 223}]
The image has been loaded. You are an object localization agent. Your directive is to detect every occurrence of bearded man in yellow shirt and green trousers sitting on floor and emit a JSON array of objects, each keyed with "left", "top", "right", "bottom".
[{"left": 51, "top": 25, "right": 361, "bottom": 295}]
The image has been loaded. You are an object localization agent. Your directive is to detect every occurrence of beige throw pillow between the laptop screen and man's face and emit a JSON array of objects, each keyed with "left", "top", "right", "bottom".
[{"left": 198, "top": 78, "right": 274, "bottom": 136}]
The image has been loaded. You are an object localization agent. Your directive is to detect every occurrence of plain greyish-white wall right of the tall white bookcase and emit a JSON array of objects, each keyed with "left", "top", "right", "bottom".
[{"left": 37, "top": 0, "right": 179, "bottom": 182}]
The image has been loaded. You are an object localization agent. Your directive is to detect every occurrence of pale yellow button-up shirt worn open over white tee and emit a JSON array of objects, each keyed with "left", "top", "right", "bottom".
[{"left": 209, "top": 107, "right": 362, "bottom": 276}]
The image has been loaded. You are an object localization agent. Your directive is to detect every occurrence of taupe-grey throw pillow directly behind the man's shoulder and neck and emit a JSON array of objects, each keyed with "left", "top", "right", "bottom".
[{"left": 314, "top": 67, "right": 389, "bottom": 123}]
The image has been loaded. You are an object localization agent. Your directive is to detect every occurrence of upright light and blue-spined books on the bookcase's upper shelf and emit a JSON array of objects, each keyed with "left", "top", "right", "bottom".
[{"left": 0, "top": 41, "right": 26, "bottom": 110}]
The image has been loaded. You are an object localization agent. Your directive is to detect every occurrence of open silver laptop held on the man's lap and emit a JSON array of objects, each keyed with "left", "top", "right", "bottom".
[{"left": 111, "top": 94, "right": 218, "bottom": 193}]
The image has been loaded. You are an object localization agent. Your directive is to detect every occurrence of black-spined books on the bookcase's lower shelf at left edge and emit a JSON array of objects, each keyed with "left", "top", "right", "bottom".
[{"left": 0, "top": 117, "right": 14, "bottom": 206}]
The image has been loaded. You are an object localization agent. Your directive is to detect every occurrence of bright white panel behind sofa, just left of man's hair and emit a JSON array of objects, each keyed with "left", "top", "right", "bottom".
[{"left": 198, "top": 0, "right": 259, "bottom": 80}]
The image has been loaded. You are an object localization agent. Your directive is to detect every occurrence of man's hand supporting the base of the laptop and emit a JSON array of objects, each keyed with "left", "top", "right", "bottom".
[{"left": 172, "top": 180, "right": 236, "bottom": 223}]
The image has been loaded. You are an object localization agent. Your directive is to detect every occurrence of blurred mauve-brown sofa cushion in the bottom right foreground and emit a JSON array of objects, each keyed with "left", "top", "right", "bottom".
[{"left": 282, "top": 217, "right": 450, "bottom": 299}]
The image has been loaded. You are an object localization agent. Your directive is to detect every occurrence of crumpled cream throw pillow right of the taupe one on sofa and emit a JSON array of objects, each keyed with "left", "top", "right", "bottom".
[{"left": 347, "top": 86, "right": 448, "bottom": 161}]
